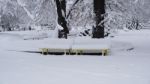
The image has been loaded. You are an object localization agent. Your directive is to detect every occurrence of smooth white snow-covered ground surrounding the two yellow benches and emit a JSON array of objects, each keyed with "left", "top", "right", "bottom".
[{"left": 0, "top": 30, "right": 150, "bottom": 84}]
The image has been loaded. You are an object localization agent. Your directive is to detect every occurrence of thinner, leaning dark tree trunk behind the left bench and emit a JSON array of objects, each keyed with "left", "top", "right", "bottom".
[{"left": 55, "top": 0, "right": 69, "bottom": 38}]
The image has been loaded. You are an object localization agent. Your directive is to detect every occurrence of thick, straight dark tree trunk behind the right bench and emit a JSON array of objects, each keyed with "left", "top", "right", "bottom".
[{"left": 93, "top": 0, "right": 105, "bottom": 38}]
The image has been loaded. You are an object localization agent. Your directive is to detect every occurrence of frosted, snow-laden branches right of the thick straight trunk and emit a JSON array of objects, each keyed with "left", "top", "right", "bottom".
[{"left": 104, "top": 0, "right": 149, "bottom": 33}]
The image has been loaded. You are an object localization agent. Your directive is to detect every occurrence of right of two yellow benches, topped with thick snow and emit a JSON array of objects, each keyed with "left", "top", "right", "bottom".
[{"left": 71, "top": 39, "right": 110, "bottom": 56}]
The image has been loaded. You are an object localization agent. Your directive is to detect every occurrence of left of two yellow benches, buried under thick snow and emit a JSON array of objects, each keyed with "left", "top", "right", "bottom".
[{"left": 40, "top": 39, "right": 73, "bottom": 54}]
